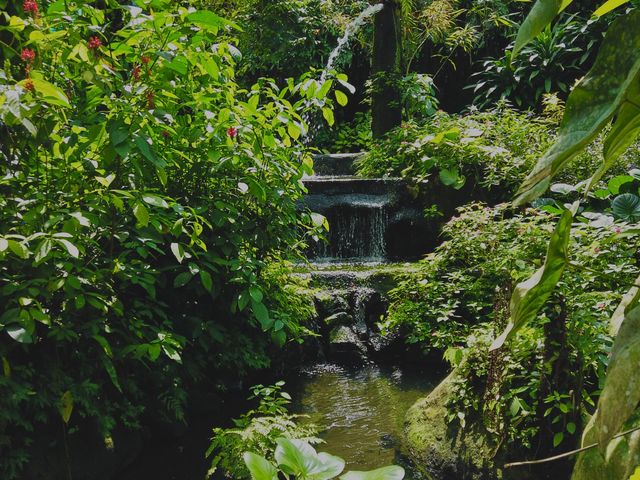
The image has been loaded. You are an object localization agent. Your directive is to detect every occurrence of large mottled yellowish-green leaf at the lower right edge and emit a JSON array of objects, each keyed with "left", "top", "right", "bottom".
[{"left": 594, "top": 306, "right": 640, "bottom": 452}]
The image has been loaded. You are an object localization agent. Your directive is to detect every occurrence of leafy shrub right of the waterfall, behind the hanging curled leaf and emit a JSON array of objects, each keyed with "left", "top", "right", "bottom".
[{"left": 385, "top": 205, "right": 640, "bottom": 447}]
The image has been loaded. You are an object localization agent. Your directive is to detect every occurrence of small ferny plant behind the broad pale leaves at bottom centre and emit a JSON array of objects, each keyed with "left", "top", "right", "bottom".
[{"left": 207, "top": 382, "right": 321, "bottom": 478}]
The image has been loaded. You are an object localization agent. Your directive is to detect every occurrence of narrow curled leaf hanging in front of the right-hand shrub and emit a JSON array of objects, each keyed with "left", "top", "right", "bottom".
[{"left": 490, "top": 210, "right": 573, "bottom": 351}]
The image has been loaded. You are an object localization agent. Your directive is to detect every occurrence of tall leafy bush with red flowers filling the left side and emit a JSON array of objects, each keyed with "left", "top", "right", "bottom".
[{"left": 0, "top": 1, "right": 332, "bottom": 479}]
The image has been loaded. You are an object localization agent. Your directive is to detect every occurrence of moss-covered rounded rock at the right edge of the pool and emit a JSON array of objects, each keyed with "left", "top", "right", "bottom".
[{"left": 404, "top": 371, "right": 502, "bottom": 480}]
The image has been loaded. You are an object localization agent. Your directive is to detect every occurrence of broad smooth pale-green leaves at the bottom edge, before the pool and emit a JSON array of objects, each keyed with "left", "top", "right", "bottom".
[{"left": 244, "top": 437, "right": 404, "bottom": 480}]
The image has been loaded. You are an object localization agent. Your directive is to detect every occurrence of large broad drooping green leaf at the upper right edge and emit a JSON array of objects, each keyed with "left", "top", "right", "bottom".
[{"left": 514, "top": 11, "right": 640, "bottom": 205}]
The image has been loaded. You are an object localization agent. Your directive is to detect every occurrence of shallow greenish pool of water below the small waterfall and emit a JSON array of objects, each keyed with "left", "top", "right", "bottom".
[{"left": 287, "top": 364, "right": 434, "bottom": 480}]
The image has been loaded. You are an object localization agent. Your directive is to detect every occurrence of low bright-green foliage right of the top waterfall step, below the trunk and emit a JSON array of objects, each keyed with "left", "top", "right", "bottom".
[{"left": 358, "top": 107, "right": 552, "bottom": 196}]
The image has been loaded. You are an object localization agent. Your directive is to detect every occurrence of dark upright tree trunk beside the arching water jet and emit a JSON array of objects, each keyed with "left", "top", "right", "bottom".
[{"left": 371, "top": 0, "right": 402, "bottom": 138}]
